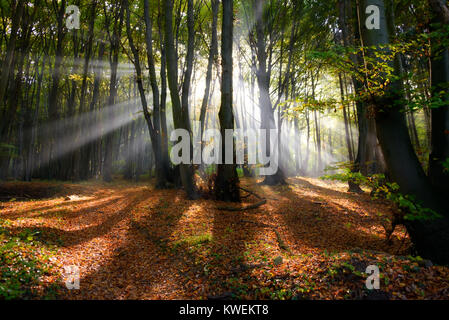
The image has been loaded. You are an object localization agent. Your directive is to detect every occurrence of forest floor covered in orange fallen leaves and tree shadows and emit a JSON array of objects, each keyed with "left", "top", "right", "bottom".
[{"left": 0, "top": 178, "right": 449, "bottom": 299}]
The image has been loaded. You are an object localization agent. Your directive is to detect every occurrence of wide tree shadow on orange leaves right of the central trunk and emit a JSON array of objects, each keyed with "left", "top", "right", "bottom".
[{"left": 276, "top": 179, "right": 407, "bottom": 254}]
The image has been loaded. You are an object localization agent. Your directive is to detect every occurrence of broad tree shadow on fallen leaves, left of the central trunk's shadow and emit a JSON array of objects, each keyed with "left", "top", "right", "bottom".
[{"left": 63, "top": 190, "right": 193, "bottom": 299}]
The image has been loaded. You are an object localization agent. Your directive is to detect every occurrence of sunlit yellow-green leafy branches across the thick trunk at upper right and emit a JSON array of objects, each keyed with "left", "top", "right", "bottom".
[{"left": 307, "top": 25, "right": 449, "bottom": 115}]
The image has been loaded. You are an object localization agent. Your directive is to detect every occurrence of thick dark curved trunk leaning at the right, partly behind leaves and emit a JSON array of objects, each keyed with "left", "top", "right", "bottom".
[{"left": 360, "top": 0, "right": 449, "bottom": 263}]
